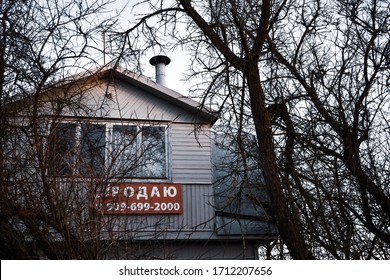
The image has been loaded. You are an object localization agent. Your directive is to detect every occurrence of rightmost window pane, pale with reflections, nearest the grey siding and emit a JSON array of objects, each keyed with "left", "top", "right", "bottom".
[{"left": 140, "top": 126, "right": 167, "bottom": 177}]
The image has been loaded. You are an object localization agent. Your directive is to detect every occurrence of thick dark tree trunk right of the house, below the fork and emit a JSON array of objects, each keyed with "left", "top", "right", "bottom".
[{"left": 245, "top": 62, "right": 314, "bottom": 259}]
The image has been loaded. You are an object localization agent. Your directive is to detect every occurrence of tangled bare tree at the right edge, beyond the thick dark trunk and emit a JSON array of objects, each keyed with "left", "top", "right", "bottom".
[{"left": 266, "top": 1, "right": 390, "bottom": 259}]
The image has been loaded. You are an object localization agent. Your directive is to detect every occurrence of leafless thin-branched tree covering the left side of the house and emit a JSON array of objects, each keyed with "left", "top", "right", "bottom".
[{"left": 0, "top": 0, "right": 157, "bottom": 259}]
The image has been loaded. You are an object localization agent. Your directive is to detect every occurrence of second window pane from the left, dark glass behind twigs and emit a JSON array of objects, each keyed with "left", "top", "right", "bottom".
[{"left": 79, "top": 124, "right": 106, "bottom": 176}]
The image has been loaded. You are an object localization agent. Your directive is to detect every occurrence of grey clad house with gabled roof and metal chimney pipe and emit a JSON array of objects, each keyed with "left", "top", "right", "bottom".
[{"left": 3, "top": 56, "right": 277, "bottom": 259}]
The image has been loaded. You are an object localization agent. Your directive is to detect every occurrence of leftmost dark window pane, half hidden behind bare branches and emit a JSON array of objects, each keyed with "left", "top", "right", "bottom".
[{"left": 48, "top": 123, "right": 76, "bottom": 176}]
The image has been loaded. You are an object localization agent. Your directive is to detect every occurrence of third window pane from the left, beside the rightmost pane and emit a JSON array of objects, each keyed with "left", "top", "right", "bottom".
[{"left": 111, "top": 125, "right": 137, "bottom": 176}]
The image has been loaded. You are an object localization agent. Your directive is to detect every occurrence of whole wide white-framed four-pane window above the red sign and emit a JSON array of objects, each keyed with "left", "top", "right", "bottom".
[{"left": 49, "top": 123, "right": 168, "bottom": 179}]
